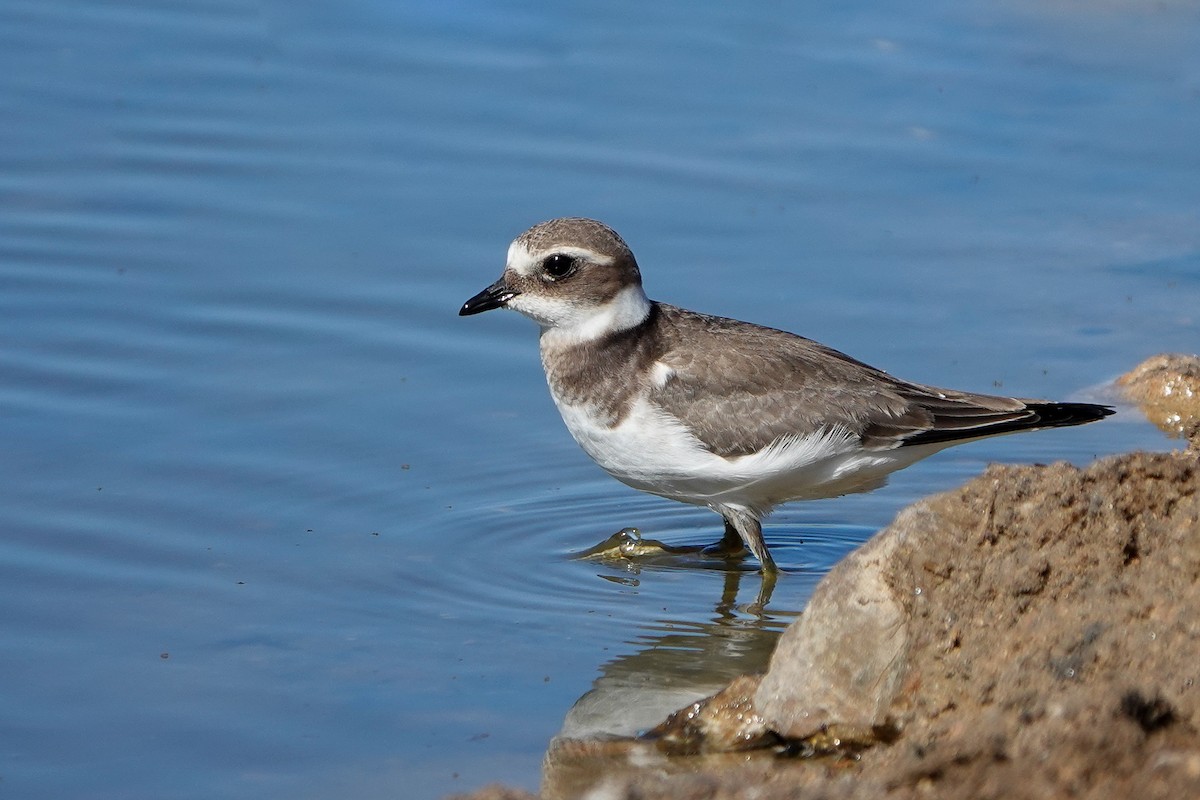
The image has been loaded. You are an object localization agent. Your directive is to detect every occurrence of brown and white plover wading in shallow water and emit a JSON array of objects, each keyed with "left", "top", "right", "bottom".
[{"left": 458, "top": 217, "right": 1112, "bottom": 573}]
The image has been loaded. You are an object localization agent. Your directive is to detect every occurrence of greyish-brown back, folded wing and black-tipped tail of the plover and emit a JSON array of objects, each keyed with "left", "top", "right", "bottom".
[{"left": 650, "top": 305, "right": 1111, "bottom": 457}]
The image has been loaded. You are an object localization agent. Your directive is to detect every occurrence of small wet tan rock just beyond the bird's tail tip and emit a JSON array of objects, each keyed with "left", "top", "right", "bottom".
[{"left": 1116, "top": 354, "right": 1200, "bottom": 447}]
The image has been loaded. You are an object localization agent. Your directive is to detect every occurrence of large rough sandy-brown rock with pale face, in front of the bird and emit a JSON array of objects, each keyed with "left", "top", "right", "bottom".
[{"left": 758, "top": 453, "right": 1200, "bottom": 798}]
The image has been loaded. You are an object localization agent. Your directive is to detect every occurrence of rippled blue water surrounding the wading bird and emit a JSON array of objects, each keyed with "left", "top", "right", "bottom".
[{"left": 0, "top": 0, "right": 1200, "bottom": 799}]
